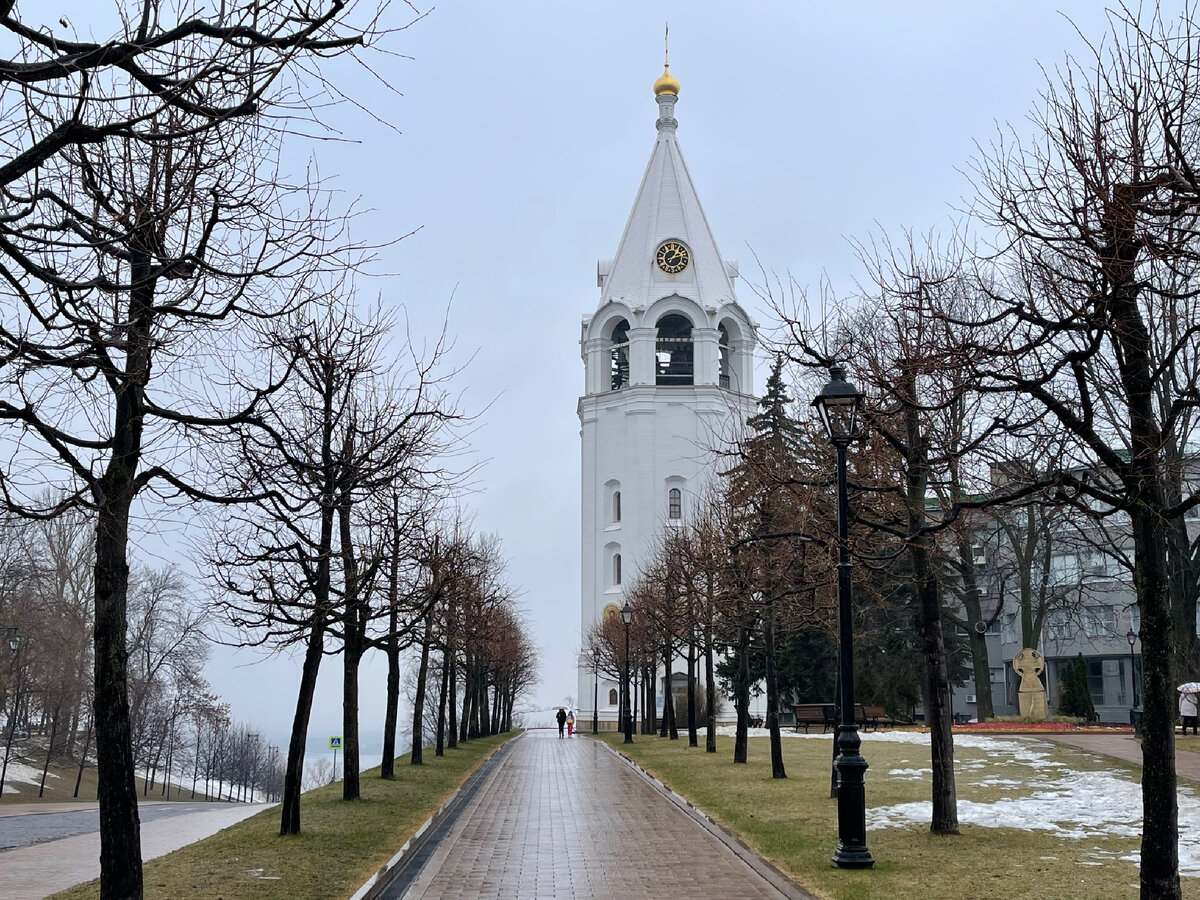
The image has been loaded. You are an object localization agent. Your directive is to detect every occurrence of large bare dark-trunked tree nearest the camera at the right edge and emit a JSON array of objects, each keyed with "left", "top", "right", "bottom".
[{"left": 977, "top": 7, "right": 1200, "bottom": 898}]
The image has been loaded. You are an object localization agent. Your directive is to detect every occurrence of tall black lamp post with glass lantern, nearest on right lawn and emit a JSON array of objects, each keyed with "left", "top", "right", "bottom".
[{"left": 812, "top": 366, "right": 875, "bottom": 869}]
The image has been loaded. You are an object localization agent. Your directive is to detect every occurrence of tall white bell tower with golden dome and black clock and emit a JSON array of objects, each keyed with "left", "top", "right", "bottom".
[{"left": 576, "top": 58, "right": 756, "bottom": 728}]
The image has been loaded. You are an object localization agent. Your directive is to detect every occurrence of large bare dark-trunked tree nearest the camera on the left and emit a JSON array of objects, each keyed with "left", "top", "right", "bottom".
[{"left": 0, "top": 0, "right": 403, "bottom": 900}]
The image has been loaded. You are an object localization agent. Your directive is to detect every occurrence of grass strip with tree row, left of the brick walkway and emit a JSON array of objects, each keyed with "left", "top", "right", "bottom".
[{"left": 54, "top": 732, "right": 520, "bottom": 900}]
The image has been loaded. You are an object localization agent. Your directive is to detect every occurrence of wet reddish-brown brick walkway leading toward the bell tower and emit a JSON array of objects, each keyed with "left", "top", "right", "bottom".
[{"left": 385, "top": 731, "right": 798, "bottom": 900}]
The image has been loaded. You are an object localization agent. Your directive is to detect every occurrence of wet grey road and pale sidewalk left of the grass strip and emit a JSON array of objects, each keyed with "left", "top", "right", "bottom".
[{"left": 0, "top": 803, "right": 275, "bottom": 900}]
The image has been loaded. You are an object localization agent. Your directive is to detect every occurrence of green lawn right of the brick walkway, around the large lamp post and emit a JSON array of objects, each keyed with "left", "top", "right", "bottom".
[{"left": 602, "top": 736, "right": 1171, "bottom": 900}]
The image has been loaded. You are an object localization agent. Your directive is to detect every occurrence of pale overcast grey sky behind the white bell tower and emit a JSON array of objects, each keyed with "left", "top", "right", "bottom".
[{"left": 30, "top": 0, "right": 1132, "bottom": 763}]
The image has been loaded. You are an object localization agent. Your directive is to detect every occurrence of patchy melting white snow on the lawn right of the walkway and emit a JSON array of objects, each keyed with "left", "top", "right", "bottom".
[{"left": 718, "top": 727, "right": 1200, "bottom": 877}]
